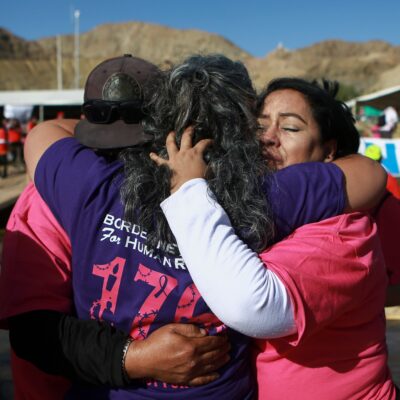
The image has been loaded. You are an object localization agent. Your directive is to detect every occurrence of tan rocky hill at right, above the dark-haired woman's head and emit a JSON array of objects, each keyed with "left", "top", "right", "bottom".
[{"left": 248, "top": 40, "right": 400, "bottom": 93}]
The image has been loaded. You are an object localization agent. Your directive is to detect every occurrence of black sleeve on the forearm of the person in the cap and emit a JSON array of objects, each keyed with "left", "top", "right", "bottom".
[{"left": 9, "top": 311, "right": 129, "bottom": 387}]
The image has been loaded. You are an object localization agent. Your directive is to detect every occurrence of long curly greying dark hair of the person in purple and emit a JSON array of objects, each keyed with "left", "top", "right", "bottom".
[{"left": 121, "top": 55, "right": 273, "bottom": 251}]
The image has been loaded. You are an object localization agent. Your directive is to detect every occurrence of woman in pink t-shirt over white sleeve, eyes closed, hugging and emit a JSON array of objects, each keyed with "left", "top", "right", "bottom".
[{"left": 152, "top": 79, "right": 396, "bottom": 400}]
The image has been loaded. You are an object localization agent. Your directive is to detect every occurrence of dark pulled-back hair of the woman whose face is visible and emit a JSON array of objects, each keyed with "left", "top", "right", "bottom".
[{"left": 257, "top": 78, "right": 360, "bottom": 158}]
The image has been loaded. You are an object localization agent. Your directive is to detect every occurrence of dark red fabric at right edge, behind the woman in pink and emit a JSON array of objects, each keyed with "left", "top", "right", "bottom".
[{"left": 375, "top": 195, "right": 400, "bottom": 285}]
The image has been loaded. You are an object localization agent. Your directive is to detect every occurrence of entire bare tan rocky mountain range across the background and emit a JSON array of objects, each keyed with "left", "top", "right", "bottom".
[{"left": 0, "top": 22, "right": 400, "bottom": 94}]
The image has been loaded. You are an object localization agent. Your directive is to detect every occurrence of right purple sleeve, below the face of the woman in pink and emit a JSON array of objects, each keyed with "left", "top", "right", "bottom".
[{"left": 263, "top": 162, "right": 346, "bottom": 240}]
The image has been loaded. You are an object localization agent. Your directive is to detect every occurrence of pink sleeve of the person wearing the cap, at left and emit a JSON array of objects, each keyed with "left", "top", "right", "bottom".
[{"left": 0, "top": 184, "right": 72, "bottom": 327}]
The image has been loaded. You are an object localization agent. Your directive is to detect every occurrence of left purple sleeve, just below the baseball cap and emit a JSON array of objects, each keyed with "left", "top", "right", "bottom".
[{"left": 35, "top": 138, "right": 120, "bottom": 237}]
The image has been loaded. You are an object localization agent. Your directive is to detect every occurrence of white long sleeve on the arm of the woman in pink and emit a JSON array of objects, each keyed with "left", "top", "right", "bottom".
[{"left": 162, "top": 179, "right": 295, "bottom": 338}]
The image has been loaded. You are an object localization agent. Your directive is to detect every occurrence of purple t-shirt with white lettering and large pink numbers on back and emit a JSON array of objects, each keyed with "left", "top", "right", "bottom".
[{"left": 35, "top": 138, "right": 344, "bottom": 400}]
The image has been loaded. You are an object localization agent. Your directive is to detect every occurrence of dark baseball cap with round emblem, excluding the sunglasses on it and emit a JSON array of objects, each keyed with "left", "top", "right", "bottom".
[{"left": 75, "top": 54, "right": 160, "bottom": 149}]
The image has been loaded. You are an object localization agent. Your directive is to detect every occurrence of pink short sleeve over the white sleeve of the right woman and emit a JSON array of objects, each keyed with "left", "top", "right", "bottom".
[{"left": 260, "top": 213, "right": 385, "bottom": 345}]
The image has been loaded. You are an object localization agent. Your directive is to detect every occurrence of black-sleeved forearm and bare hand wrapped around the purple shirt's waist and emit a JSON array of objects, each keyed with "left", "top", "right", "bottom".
[{"left": 9, "top": 310, "right": 230, "bottom": 387}]
